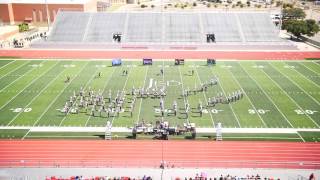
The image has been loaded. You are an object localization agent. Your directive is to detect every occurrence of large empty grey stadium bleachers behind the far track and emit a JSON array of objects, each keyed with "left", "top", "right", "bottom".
[{"left": 33, "top": 11, "right": 294, "bottom": 49}]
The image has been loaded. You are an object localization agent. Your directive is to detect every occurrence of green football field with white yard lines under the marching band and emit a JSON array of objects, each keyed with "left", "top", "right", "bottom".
[{"left": 0, "top": 59, "right": 320, "bottom": 140}]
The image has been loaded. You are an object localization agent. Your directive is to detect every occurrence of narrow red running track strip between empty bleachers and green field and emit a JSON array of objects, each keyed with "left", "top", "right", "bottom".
[{"left": 0, "top": 49, "right": 320, "bottom": 60}]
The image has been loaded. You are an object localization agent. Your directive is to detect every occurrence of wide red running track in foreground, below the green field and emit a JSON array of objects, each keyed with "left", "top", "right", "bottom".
[{"left": 0, "top": 140, "right": 320, "bottom": 169}]
